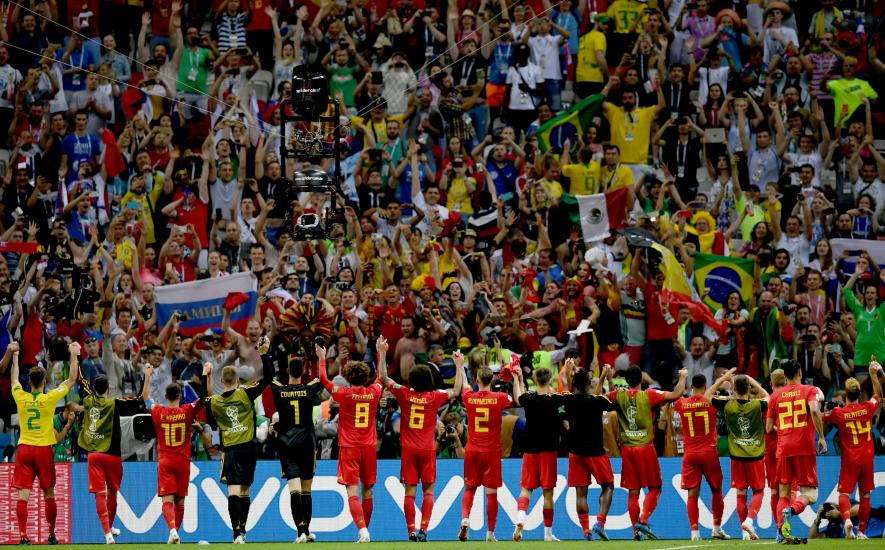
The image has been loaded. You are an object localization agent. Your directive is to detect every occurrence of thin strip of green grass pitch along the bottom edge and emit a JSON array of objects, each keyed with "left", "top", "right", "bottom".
[{"left": 51, "top": 533, "right": 885, "bottom": 550}]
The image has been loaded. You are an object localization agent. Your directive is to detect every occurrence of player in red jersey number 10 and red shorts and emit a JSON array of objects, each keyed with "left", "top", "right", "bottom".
[{"left": 151, "top": 364, "right": 211, "bottom": 544}]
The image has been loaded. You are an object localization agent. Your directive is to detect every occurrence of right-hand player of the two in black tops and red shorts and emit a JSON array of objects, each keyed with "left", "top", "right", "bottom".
[{"left": 565, "top": 364, "right": 615, "bottom": 540}]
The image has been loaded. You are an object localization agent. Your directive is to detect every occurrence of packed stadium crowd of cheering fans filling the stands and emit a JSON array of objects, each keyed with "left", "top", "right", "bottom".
[{"left": 0, "top": 0, "right": 885, "bottom": 490}]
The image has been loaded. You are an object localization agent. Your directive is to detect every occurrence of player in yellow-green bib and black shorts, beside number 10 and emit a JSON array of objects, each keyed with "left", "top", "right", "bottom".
[{"left": 205, "top": 337, "right": 274, "bottom": 544}]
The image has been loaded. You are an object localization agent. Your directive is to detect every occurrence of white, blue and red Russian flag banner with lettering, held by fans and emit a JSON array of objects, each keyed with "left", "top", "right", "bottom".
[{"left": 154, "top": 273, "right": 258, "bottom": 336}]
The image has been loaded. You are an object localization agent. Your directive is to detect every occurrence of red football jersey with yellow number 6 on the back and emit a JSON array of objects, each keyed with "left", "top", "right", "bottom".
[{"left": 390, "top": 384, "right": 449, "bottom": 451}]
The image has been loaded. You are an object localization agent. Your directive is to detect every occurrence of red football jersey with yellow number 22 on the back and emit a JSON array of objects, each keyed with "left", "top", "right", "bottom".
[{"left": 768, "top": 384, "right": 822, "bottom": 458}]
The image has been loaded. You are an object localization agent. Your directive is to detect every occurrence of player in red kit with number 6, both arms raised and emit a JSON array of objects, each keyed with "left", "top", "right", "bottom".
[{"left": 377, "top": 336, "right": 466, "bottom": 542}]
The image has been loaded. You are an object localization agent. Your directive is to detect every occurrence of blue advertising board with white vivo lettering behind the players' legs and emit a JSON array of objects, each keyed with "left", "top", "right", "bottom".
[{"left": 0, "top": 457, "right": 885, "bottom": 543}]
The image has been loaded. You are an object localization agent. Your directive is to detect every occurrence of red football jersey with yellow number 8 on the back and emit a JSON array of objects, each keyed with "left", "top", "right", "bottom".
[{"left": 332, "top": 382, "right": 382, "bottom": 447}]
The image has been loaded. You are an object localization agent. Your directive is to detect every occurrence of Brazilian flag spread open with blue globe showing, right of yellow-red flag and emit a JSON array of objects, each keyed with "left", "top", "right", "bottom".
[{"left": 694, "top": 252, "right": 755, "bottom": 312}]
